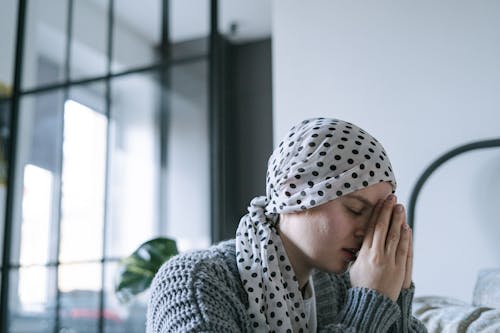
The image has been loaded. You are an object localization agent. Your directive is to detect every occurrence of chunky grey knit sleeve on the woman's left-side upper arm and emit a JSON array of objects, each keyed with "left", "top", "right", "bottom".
[{"left": 147, "top": 252, "right": 250, "bottom": 333}]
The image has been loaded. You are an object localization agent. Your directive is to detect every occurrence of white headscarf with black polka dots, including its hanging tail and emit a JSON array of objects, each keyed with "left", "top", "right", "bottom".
[{"left": 236, "top": 118, "right": 396, "bottom": 332}]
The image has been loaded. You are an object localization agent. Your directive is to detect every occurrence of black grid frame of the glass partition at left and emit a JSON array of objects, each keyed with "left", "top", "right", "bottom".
[{"left": 0, "top": 0, "right": 229, "bottom": 332}]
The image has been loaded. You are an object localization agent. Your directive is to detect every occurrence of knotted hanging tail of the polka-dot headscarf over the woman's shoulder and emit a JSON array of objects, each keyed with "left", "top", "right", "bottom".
[{"left": 236, "top": 196, "right": 308, "bottom": 332}]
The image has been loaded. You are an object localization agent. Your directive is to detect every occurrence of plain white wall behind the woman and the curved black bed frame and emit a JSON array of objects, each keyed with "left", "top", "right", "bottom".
[{"left": 273, "top": 0, "right": 500, "bottom": 301}]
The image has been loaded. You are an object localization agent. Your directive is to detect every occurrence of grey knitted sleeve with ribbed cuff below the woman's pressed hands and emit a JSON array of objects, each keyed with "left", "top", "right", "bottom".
[{"left": 314, "top": 272, "right": 427, "bottom": 333}]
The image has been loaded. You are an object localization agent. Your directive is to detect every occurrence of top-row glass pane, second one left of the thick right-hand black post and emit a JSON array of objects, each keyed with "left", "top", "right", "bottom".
[{"left": 111, "top": 0, "right": 162, "bottom": 72}]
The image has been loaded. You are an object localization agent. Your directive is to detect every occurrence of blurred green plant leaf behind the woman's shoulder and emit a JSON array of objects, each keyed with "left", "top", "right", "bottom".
[{"left": 115, "top": 237, "right": 179, "bottom": 303}]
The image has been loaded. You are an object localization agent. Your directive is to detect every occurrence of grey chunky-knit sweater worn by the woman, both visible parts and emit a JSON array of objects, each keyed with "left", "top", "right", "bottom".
[{"left": 147, "top": 240, "right": 427, "bottom": 333}]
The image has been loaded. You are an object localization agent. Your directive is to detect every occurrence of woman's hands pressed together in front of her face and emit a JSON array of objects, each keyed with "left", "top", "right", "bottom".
[{"left": 349, "top": 195, "right": 413, "bottom": 301}]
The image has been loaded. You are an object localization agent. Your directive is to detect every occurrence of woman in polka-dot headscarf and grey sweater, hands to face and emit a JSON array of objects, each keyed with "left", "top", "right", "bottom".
[{"left": 147, "top": 118, "right": 426, "bottom": 333}]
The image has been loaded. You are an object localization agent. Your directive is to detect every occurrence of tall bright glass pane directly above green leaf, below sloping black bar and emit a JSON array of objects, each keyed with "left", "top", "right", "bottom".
[{"left": 106, "top": 70, "right": 161, "bottom": 257}]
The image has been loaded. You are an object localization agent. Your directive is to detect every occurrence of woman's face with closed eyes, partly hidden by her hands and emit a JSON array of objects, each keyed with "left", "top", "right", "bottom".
[{"left": 279, "top": 182, "right": 392, "bottom": 273}]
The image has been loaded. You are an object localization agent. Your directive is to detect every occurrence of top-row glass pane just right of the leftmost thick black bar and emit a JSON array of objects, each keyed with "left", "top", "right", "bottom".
[{"left": 22, "top": 0, "right": 68, "bottom": 89}]
